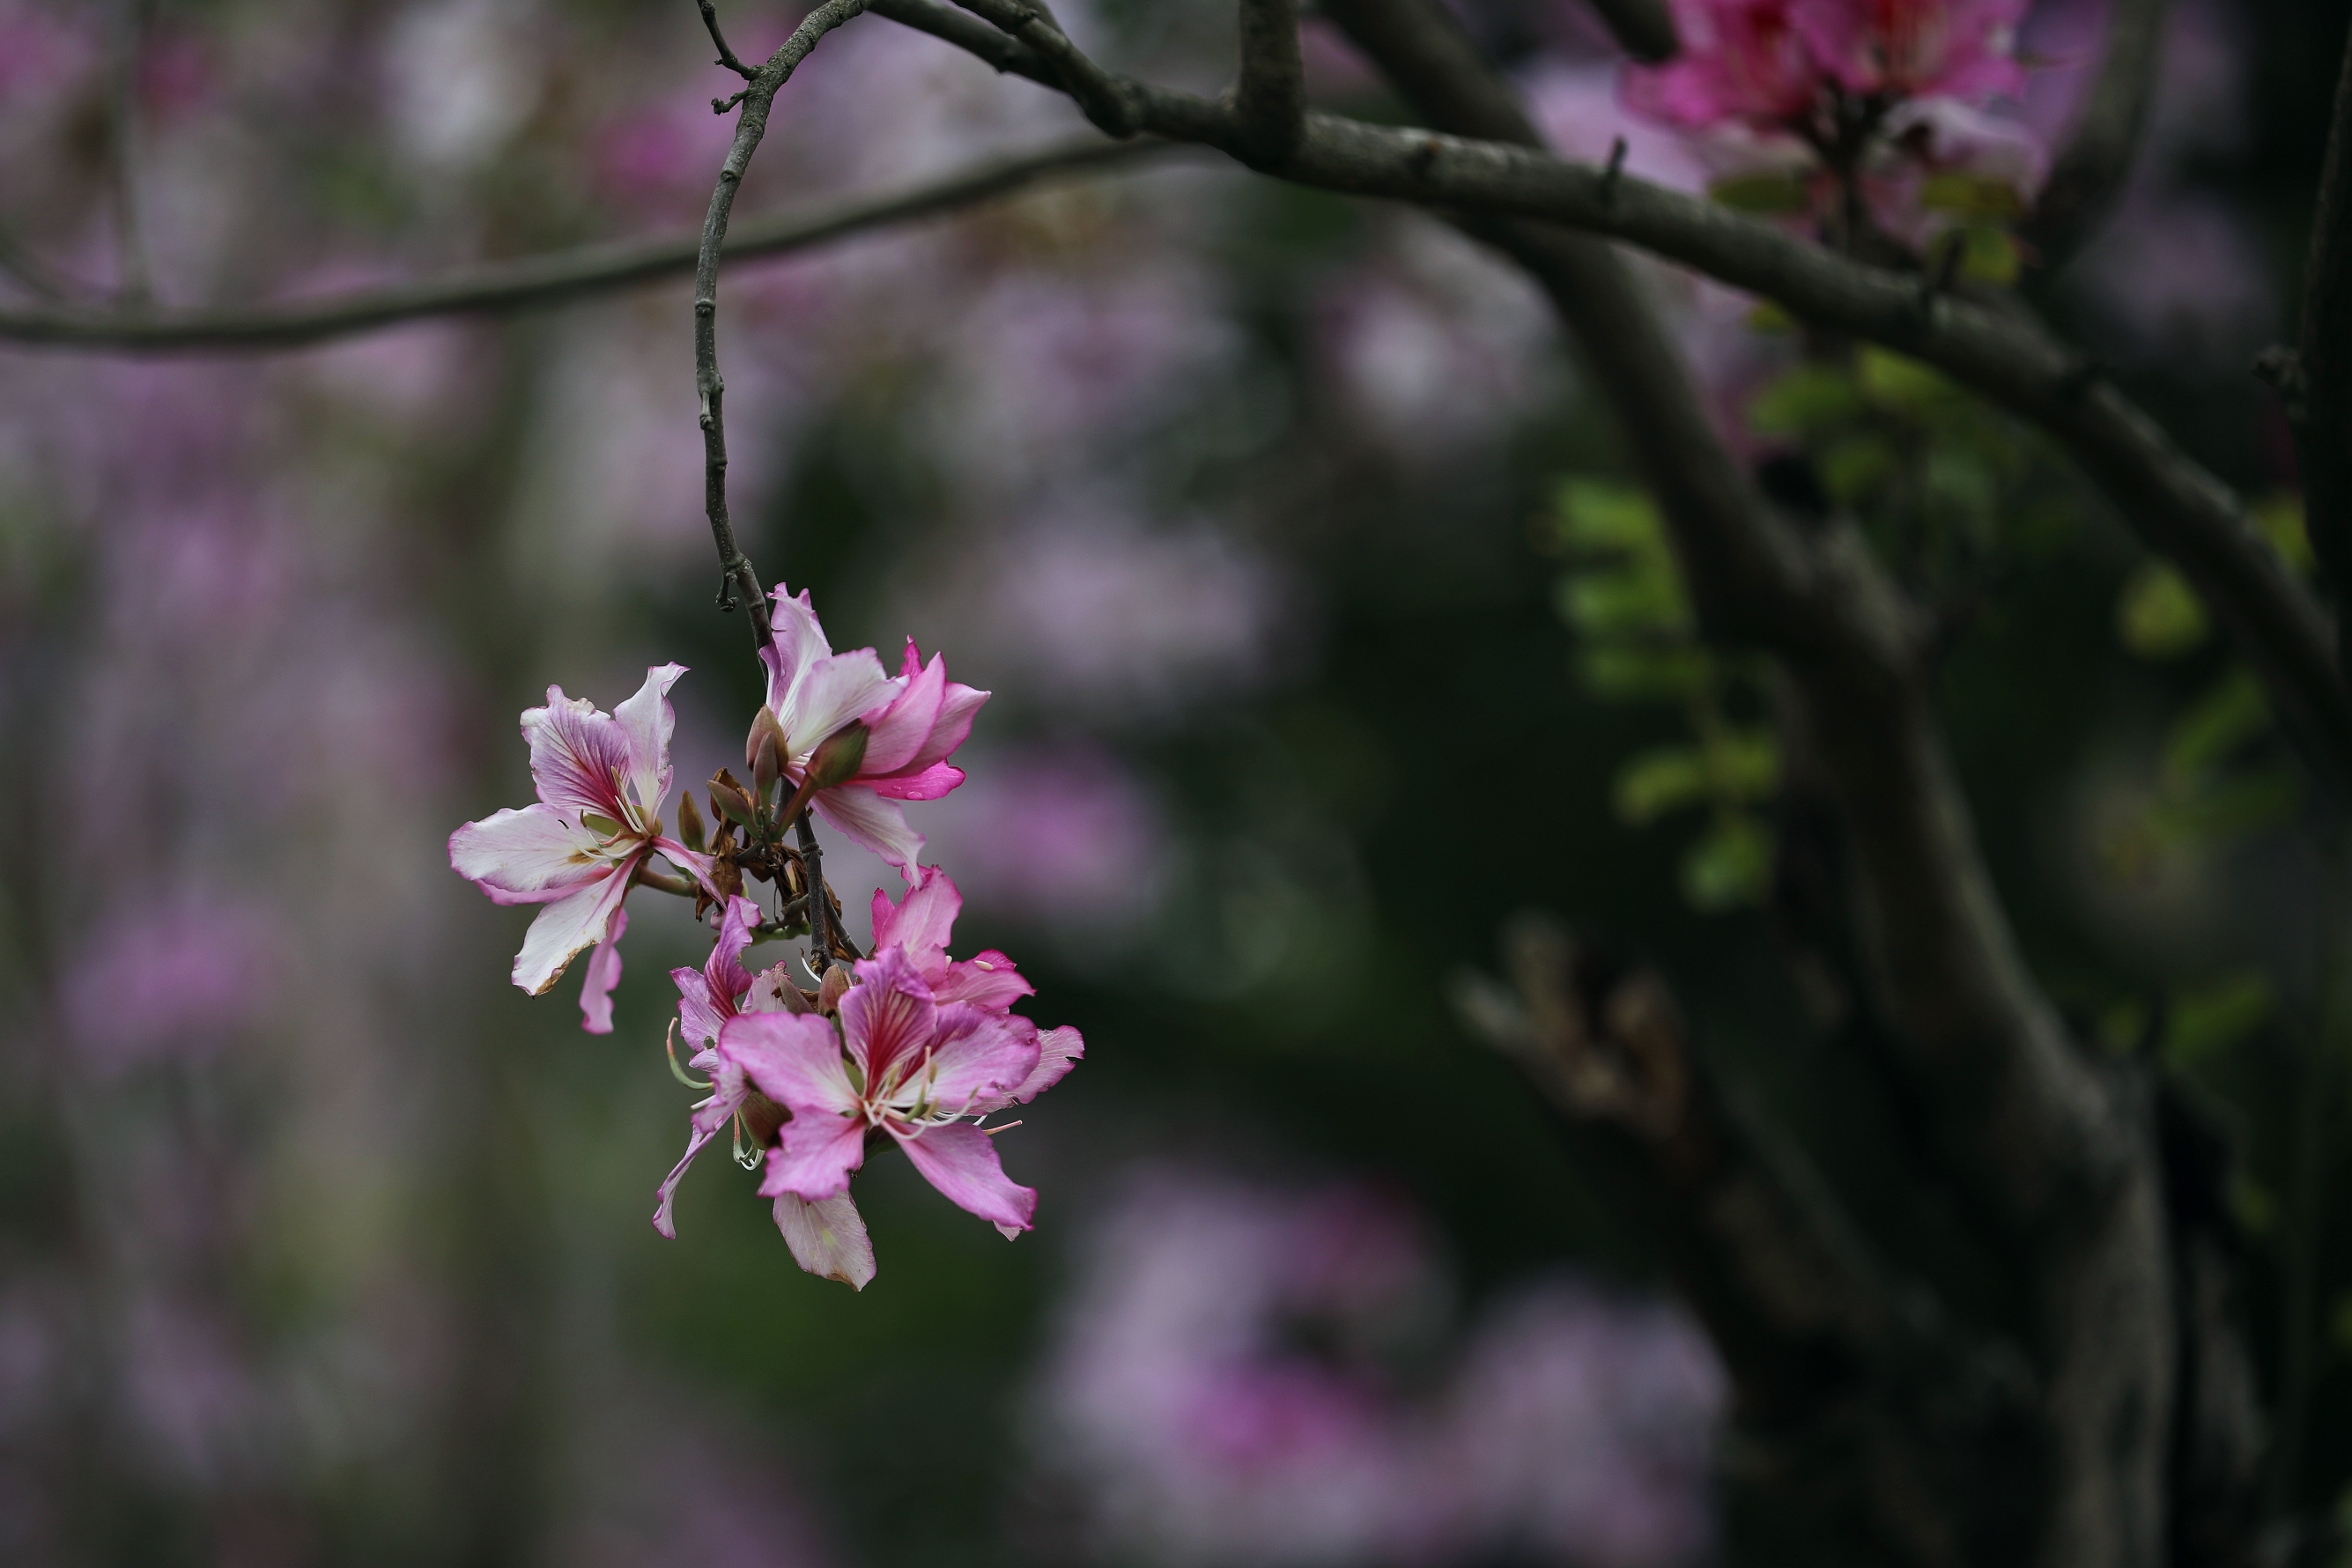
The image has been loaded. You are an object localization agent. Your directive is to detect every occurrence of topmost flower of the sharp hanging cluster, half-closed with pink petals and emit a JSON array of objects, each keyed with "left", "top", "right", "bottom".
[{"left": 759, "top": 585, "right": 987, "bottom": 879}]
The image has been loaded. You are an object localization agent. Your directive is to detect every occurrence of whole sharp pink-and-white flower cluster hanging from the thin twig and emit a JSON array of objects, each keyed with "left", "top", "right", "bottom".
[{"left": 449, "top": 588, "right": 1084, "bottom": 1288}]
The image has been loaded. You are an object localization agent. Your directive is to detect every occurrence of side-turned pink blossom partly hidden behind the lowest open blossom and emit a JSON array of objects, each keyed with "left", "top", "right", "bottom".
[{"left": 654, "top": 898, "right": 875, "bottom": 1291}]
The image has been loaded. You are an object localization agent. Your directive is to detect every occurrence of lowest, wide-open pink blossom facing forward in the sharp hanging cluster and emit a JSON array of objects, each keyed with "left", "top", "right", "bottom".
[{"left": 696, "top": 868, "right": 1084, "bottom": 1283}]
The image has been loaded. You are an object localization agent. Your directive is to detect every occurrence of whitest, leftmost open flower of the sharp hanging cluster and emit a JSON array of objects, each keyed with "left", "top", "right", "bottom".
[{"left": 449, "top": 665, "right": 710, "bottom": 1034}]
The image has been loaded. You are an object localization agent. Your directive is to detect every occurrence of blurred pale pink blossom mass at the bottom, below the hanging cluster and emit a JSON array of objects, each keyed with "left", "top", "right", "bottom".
[{"left": 1035, "top": 1168, "right": 1724, "bottom": 1568}]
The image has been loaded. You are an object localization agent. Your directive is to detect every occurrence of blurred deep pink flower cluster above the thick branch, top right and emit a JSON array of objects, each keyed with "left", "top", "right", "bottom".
[{"left": 1623, "top": 0, "right": 2046, "bottom": 247}]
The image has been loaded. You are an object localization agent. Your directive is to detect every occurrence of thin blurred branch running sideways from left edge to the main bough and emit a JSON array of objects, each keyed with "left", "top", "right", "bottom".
[{"left": 0, "top": 137, "right": 1173, "bottom": 352}]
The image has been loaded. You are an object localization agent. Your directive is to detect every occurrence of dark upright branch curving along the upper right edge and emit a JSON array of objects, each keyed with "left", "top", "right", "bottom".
[{"left": 2286, "top": 19, "right": 2352, "bottom": 679}]
